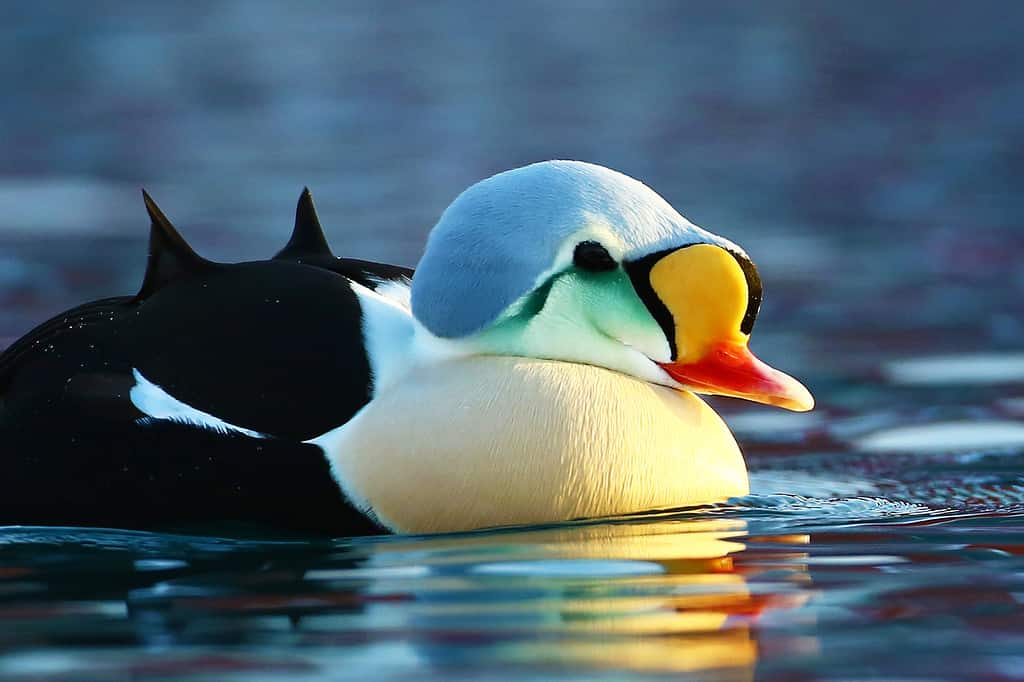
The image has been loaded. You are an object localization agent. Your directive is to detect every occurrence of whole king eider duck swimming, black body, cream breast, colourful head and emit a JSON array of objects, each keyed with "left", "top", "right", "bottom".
[{"left": 0, "top": 161, "right": 813, "bottom": 535}]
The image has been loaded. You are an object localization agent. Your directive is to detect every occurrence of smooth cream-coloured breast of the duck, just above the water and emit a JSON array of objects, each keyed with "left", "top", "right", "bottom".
[{"left": 313, "top": 356, "right": 749, "bottom": 532}]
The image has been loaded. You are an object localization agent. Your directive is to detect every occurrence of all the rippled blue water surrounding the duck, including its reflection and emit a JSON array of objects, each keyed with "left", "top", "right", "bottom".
[{"left": 0, "top": 0, "right": 1024, "bottom": 682}]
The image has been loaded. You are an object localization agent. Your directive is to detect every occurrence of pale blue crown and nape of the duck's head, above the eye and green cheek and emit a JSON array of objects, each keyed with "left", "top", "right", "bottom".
[{"left": 413, "top": 161, "right": 736, "bottom": 338}]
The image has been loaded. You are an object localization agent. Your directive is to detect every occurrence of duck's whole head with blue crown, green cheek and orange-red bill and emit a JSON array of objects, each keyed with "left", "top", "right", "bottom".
[{"left": 412, "top": 161, "right": 814, "bottom": 411}]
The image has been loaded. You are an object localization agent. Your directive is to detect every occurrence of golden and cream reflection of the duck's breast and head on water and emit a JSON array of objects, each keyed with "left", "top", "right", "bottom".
[{"left": 300, "top": 519, "right": 814, "bottom": 679}]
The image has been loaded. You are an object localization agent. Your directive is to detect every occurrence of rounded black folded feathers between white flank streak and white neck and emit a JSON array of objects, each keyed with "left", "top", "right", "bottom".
[{"left": 118, "top": 261, "right": 371, "bottom": 440}]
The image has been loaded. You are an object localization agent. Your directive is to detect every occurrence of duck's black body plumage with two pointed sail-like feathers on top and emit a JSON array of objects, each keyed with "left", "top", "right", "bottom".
[{"left": 0, "top": 188, "right": 412, "bottom": 535}]
